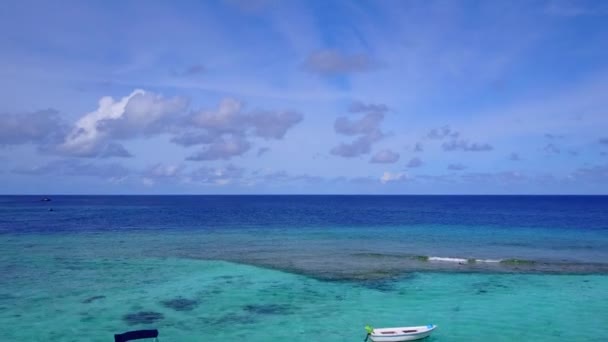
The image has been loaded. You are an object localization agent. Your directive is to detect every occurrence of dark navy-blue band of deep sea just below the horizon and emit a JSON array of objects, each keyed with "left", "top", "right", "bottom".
[{"left": 0, "top": 196, "right": 608, "bottom": 232}]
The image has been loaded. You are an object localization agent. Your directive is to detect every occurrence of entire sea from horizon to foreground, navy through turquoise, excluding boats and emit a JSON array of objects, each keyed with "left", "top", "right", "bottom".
[{"left": 0, "top": 195, "right": 608, "bottom": 342}]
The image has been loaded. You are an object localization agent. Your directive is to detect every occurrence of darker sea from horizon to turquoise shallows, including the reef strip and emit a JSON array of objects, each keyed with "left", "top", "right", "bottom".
[{"left": 0, "top": 196, "right": 608, "bottom": 273}]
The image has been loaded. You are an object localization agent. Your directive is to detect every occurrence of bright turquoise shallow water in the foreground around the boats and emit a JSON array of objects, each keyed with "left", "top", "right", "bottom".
[{"left": 0, "top": 232, "right": 608, "bottom": 342}]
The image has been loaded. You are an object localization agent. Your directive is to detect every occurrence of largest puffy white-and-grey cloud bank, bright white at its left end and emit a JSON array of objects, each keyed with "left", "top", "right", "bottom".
[{"left": 47, "top": 89, "right": 303, "bottom": 160}]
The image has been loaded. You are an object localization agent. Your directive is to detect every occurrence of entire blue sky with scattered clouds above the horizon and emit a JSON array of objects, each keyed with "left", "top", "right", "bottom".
[{"left": 0, "top": 0, "right": 608, "bottom": 194}]
